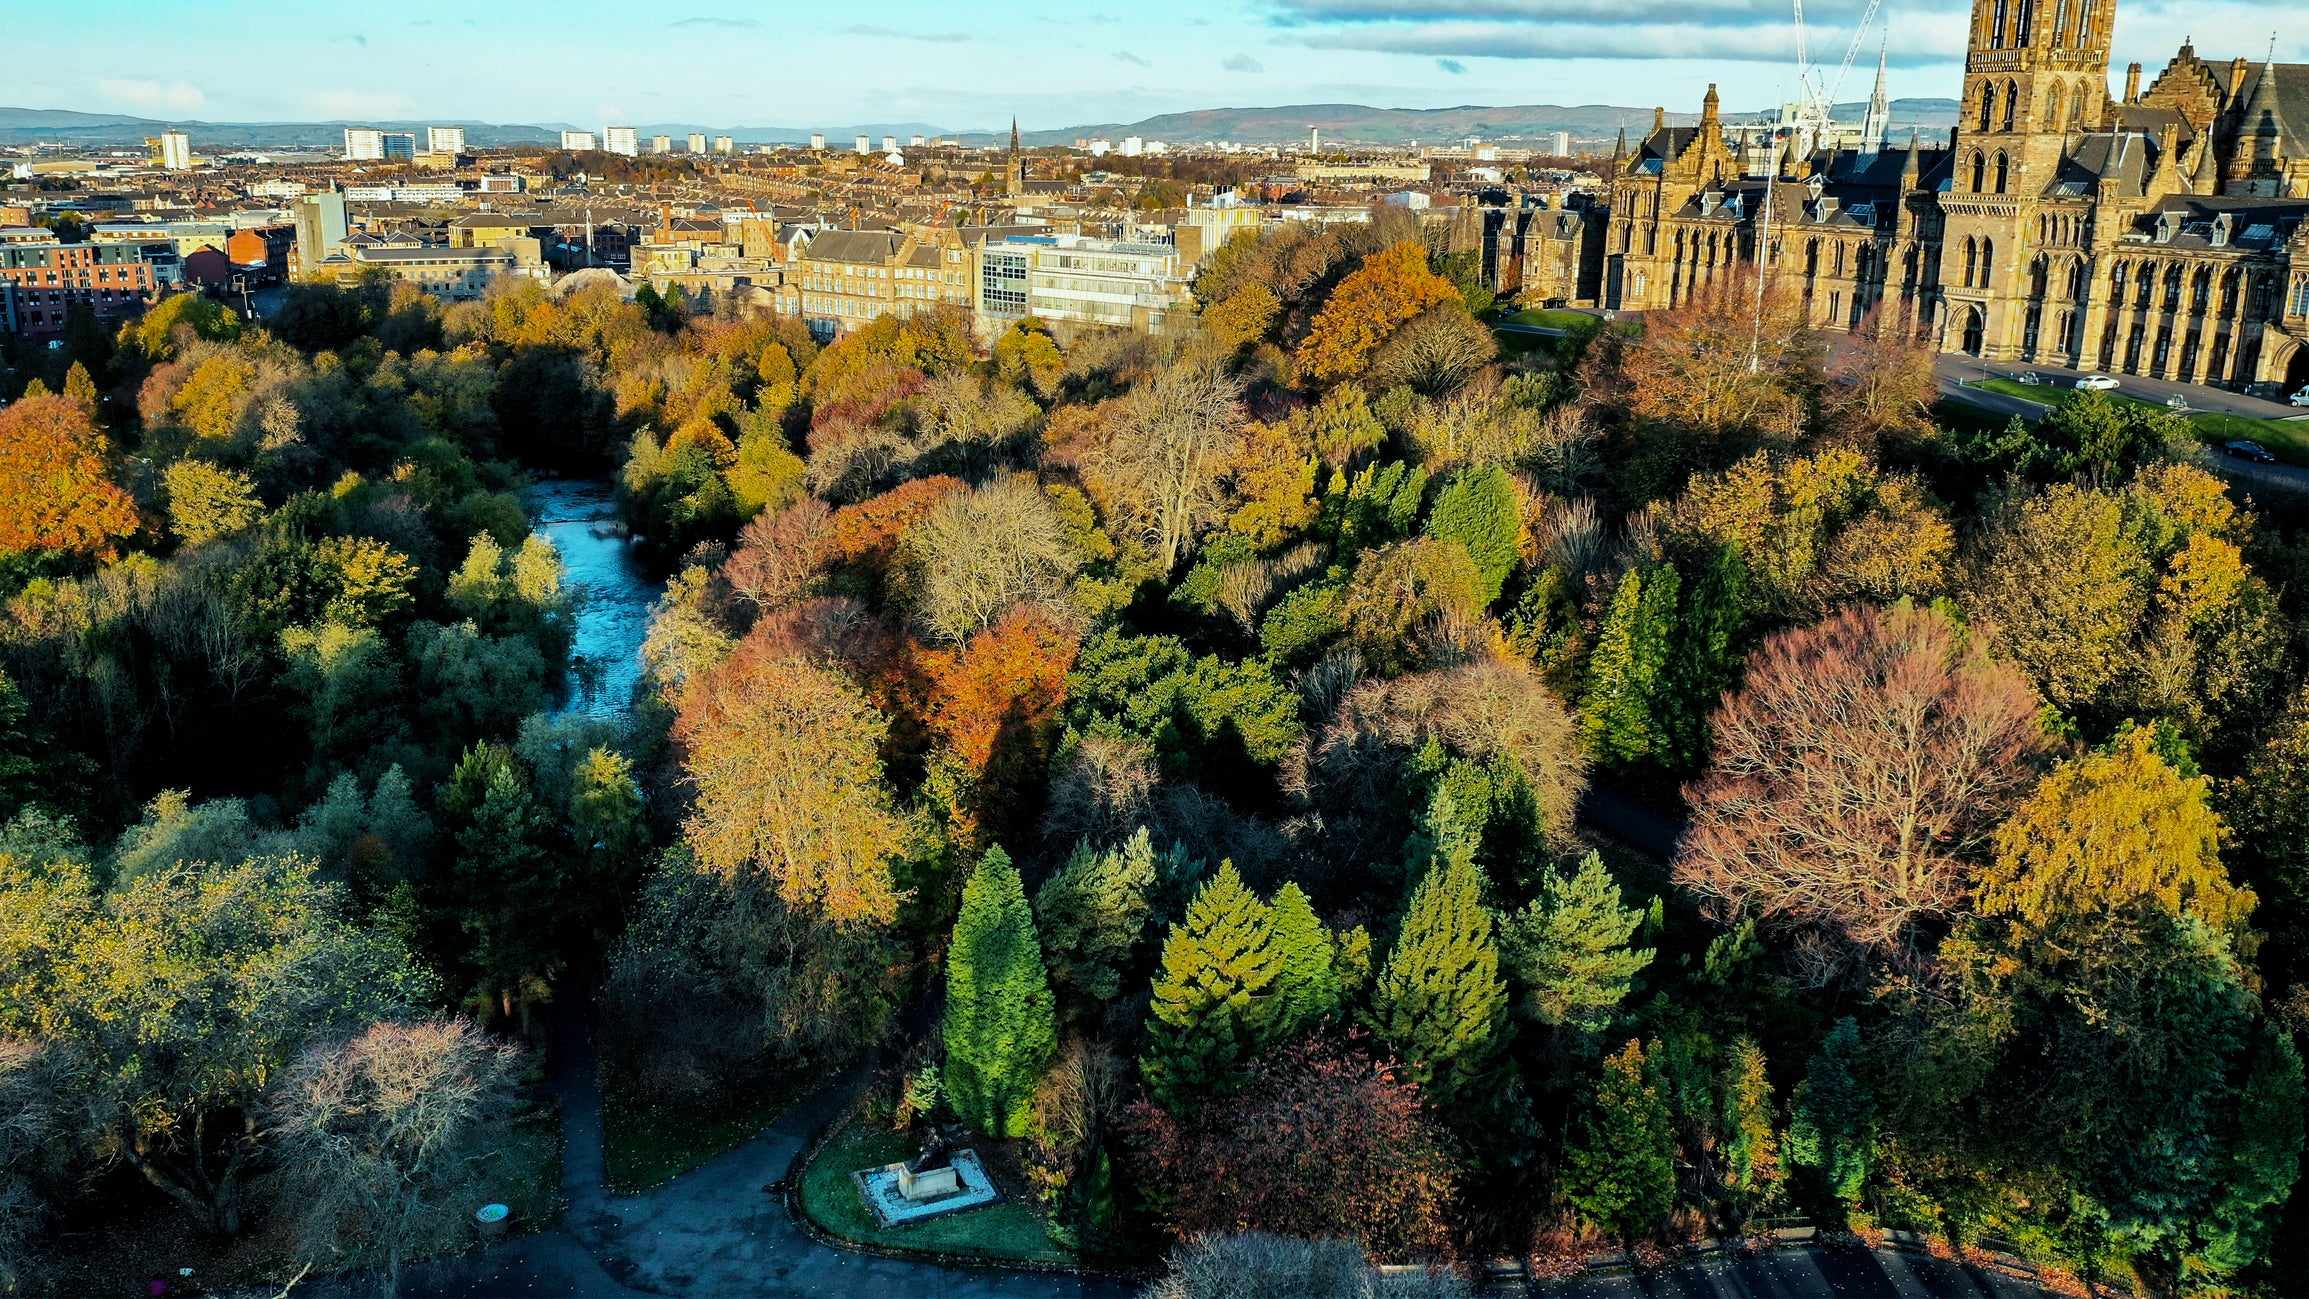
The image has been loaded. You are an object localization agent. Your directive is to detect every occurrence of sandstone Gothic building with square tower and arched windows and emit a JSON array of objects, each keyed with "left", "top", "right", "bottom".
[{"left": 1591, "top": 0, "right": 2309, "bottom": 395}]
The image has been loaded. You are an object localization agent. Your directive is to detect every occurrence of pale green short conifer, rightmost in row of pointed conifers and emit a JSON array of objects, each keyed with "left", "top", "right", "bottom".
[{"left": 1501, "top": 854, "right": 1653, "bottom": 1034}]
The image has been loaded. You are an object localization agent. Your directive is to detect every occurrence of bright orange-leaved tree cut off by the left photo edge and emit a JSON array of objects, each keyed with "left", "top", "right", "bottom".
[{"left": 0, "top": 397, "right": 139, "bottom": 554}]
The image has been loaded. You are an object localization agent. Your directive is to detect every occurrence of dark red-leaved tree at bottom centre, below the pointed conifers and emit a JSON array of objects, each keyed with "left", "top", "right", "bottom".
[{"left": 1124, "top": 1043, "right": 1452, "bottom": 1260}]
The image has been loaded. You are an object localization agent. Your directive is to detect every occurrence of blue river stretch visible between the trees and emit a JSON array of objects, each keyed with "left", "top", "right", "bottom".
[{"left": 529, "top": 478, "right": 660, "bottom": 718}]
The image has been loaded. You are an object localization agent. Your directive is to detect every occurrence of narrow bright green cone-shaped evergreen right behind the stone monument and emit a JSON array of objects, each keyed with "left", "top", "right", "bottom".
[{"left": 944, "top": 847, "right": 1058, "bottom": 1137}]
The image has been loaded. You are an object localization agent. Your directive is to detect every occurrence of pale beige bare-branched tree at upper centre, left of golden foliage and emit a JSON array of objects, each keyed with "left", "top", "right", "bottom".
[{"left": 1085, "top": 367, "right": 1242, "bottom": 572}]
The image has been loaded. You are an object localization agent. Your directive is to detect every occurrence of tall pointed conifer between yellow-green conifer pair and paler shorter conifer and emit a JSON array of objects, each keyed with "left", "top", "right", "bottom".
[{"left": 1369, "top": 794, "right": 1508, "bottom": 1107}]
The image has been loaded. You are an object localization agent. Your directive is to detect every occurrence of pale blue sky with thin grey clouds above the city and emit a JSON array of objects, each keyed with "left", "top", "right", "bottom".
[{"left": 18, "top": 0, "right": 2309, "bottom": 132}]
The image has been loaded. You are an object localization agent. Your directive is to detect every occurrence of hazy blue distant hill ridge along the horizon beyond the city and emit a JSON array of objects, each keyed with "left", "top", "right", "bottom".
[{"left": 0, "top": 99, "right": 1956, "bottom": 150}]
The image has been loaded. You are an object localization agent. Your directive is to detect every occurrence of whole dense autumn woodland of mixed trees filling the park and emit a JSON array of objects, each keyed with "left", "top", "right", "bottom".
[{"left": 0, "top": 212, "right": 2309, "bottom": 1299}]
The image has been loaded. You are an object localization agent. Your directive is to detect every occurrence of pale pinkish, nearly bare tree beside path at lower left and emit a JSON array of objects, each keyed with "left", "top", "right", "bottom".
[{"left": 266, "top": 1020, "right": 522, "bottom": 1294}]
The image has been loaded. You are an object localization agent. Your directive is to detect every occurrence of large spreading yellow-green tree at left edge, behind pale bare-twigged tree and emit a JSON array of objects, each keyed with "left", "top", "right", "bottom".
[{"left": 0, "top": 856, "right": 434, "bottom": 1234}]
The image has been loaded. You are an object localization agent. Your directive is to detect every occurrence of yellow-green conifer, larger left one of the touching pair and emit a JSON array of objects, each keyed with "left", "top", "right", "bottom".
[{"left": 1138, "top": 861, "right": 1284, "bottom": 1112}]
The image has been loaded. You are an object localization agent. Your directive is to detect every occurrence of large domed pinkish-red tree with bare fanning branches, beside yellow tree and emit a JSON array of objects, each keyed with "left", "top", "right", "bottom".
[{"left": 1676, "top": 607, "right": 2043, "bottom": 978}]
